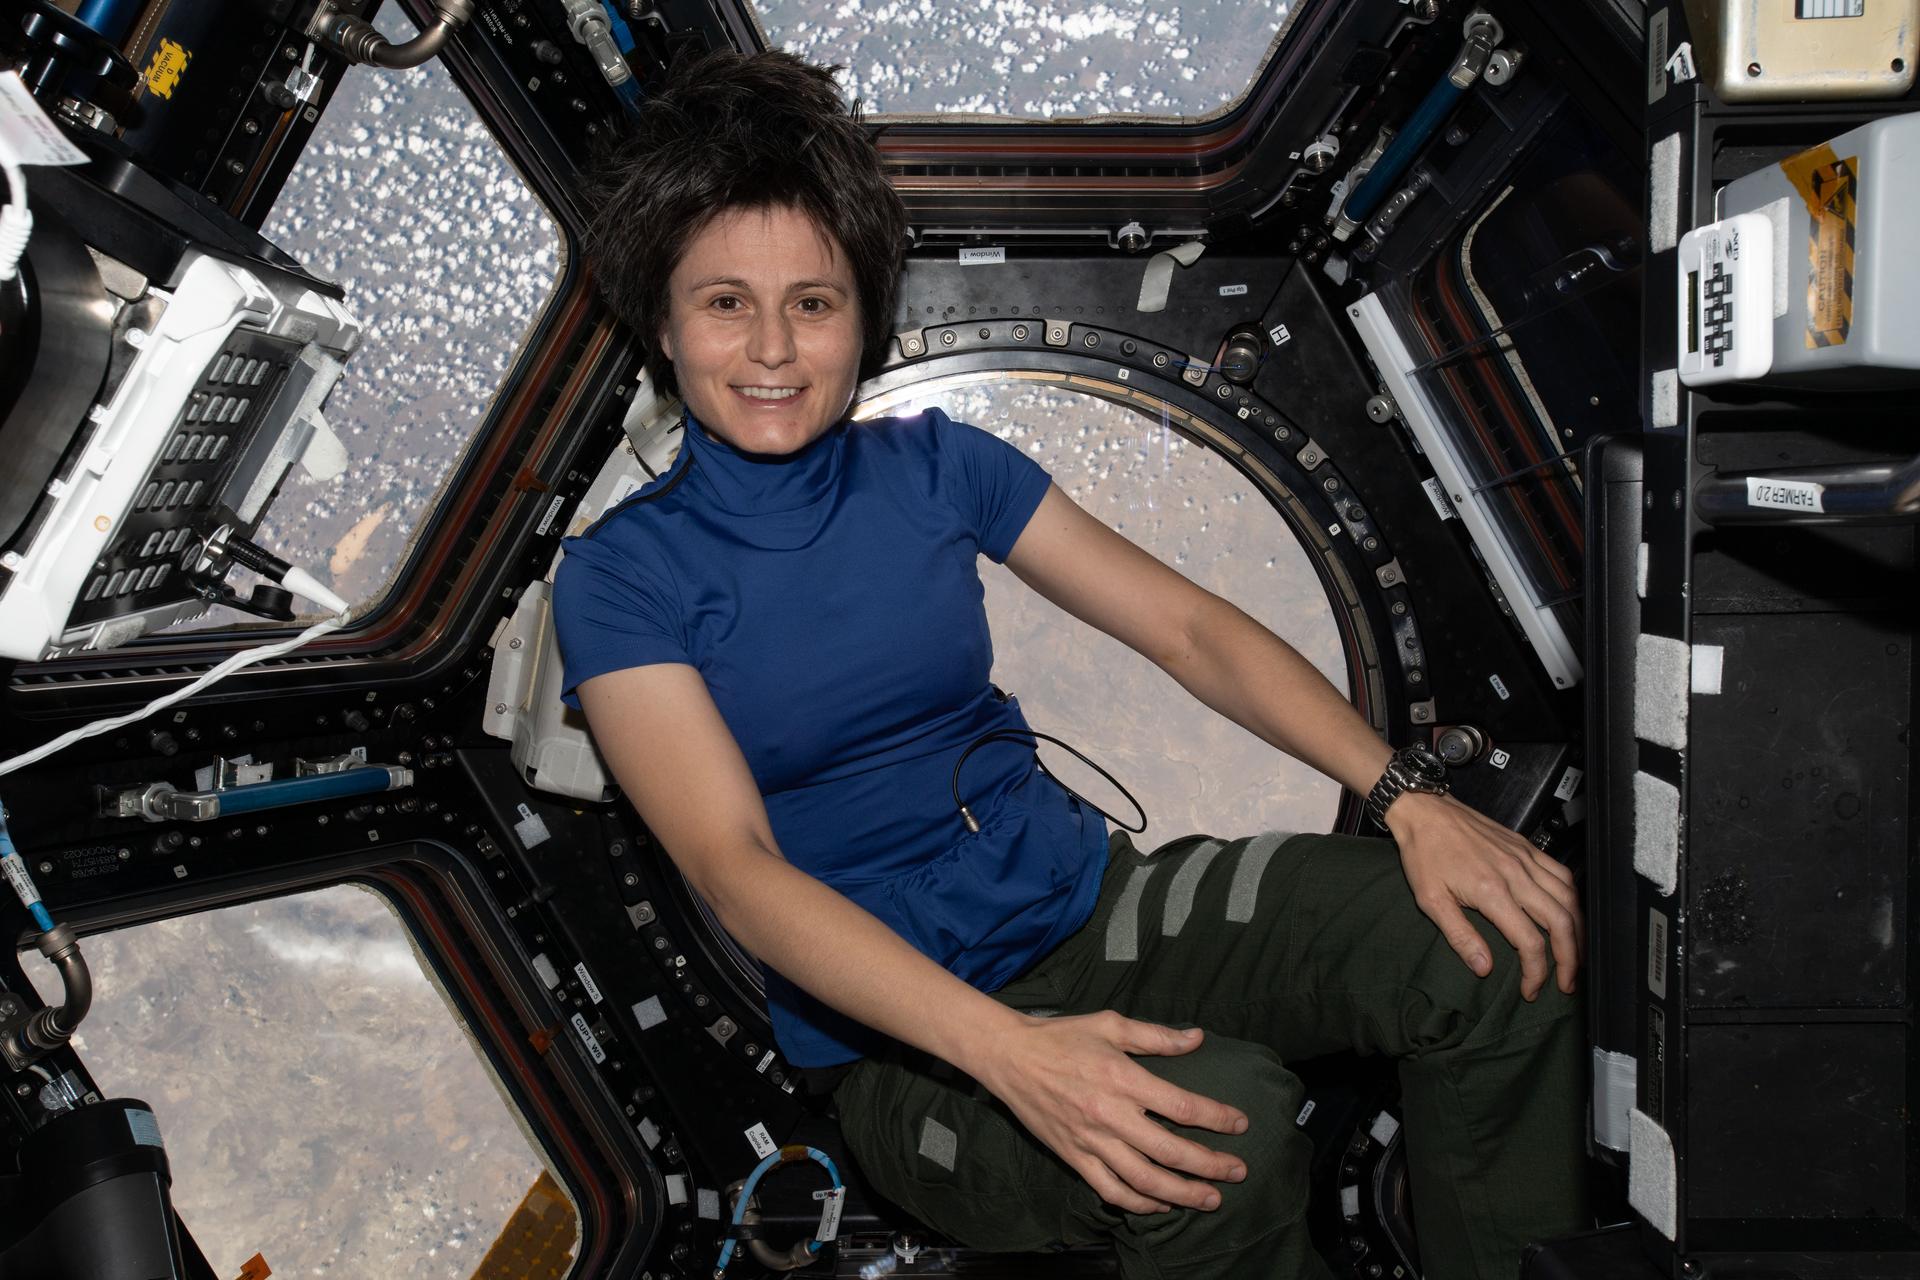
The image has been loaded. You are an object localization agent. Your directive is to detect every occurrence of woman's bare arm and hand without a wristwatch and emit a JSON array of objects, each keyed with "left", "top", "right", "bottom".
[{"left": 580, "top": 664, "right": 1246, "bottom": 1213}]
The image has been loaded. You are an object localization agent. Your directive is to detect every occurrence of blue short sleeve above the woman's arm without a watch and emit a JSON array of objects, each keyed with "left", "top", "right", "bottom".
[{"left": 553, "top": 537, "right": 693, "bottom": 708}]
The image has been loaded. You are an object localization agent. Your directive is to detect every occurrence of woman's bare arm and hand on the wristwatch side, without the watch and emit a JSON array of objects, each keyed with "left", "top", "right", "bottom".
[{"left": 1006, "top": 486, "right": 1584, "bottom": 1000}]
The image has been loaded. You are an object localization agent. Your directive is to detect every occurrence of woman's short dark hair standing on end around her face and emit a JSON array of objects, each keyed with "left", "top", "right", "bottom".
[{"left": 584, "top": 50, "right": 906, "bottom": 393}]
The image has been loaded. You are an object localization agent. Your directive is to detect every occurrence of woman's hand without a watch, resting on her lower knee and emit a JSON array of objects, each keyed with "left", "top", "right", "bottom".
[{"left": 972, "top": 1009, "right": 1248, "bottom": 1213}]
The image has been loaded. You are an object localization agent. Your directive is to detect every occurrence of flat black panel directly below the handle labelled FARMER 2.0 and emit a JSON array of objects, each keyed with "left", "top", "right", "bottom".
[{"left": 1688, "top": 614, "right": 1912, "bottom": 1007}]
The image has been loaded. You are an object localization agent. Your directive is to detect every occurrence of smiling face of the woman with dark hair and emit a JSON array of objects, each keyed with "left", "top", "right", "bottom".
[{"left": 660, "top": 207, "right": 860, "bottom": 453}]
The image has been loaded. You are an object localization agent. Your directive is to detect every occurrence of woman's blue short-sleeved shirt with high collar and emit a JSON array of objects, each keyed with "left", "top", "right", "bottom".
[{"left": 553, "top": 409, "right": 1106, "bottom": 1067}]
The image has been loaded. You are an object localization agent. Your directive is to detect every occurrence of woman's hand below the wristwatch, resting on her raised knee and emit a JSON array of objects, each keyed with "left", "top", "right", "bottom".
[{"left": 1386, "top": 791, "right": 1586, "bottom": 1000}]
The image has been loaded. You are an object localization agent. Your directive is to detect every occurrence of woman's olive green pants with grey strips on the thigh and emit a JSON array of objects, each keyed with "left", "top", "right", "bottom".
[{"left": 833, "top": 833, "right": 1590, "bottom": 1280}]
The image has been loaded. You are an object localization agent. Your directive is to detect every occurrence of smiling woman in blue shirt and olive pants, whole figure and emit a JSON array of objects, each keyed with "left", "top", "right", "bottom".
[{"left": 553, "top": 42, "right": 1582, "bottom": 1280}]
